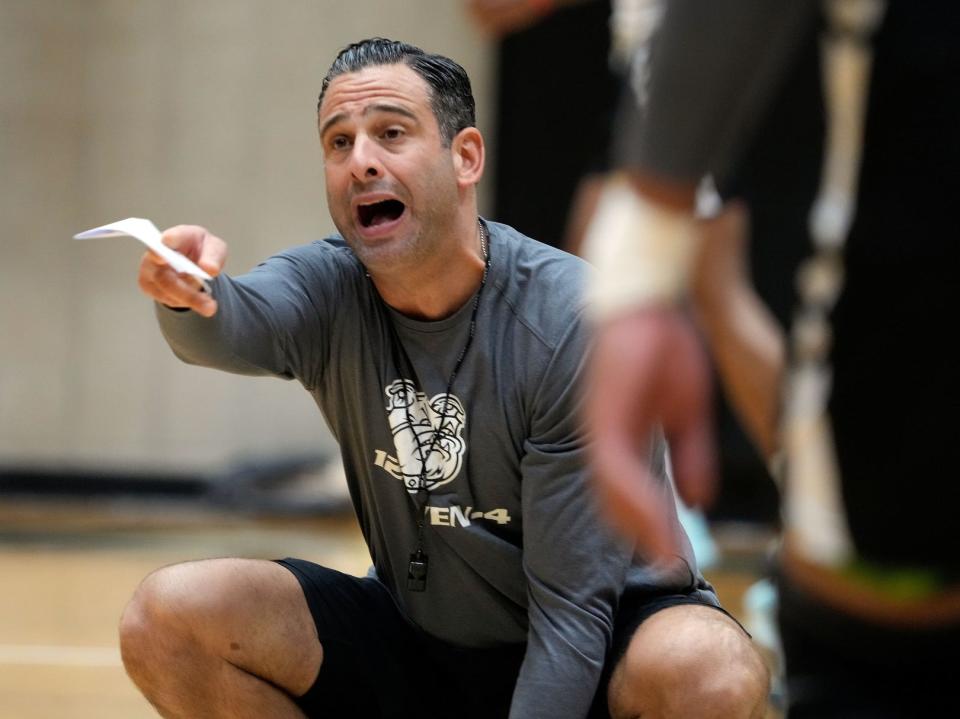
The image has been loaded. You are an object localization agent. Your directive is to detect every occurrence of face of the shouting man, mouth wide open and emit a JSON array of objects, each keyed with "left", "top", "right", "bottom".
[{"left": 319, "top": 64, "right": 459, "bottom": 272}]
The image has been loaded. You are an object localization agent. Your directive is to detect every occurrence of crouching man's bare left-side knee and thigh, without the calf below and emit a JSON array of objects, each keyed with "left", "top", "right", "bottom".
[{"left": 120, "top": 559, "right": 323, "bottom": 695}]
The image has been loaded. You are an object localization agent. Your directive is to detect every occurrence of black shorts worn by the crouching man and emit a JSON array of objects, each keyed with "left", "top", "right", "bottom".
[{"left": 278, "top": 558, "right": 736, "bottom": 719}]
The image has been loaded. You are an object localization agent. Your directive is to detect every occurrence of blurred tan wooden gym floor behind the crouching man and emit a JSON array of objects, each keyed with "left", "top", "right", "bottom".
[{"left": 0, "top": 502, "right": 780, "bottom": 719}]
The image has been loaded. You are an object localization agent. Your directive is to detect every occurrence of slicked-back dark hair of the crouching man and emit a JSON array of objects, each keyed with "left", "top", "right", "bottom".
[{"left": 317, "top": 37, "right": 476, "bottom": 145}]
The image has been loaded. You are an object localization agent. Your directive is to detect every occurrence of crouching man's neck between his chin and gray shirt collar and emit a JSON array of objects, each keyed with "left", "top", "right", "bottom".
[{"left": 371, "top": 220, "right": 489, "bottom": 321}]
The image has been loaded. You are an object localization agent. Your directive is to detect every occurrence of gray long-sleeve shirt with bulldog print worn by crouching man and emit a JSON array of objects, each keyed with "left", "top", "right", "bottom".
[{"left": 158, "top": 223, "right": 710, "bottom": 719}]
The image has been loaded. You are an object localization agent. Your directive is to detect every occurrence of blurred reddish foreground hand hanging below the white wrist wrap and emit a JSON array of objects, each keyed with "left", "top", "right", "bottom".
[{"left": 586, "top": 307, "right": 716, "bottom": 559}]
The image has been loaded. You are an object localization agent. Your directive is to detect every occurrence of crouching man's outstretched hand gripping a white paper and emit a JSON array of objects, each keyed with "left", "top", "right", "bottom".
[{"left": 139, "top": 225, "right": 227, "bottom": 317}]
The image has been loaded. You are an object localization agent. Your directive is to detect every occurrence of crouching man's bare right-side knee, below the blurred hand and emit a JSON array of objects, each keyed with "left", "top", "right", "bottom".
[{"left": 607, "top": 604, "right": 770, "bottom": 719}]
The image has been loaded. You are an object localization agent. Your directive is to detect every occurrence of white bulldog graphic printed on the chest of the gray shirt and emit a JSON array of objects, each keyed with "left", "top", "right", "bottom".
[{"left": 377, "top": 379, "right": 466, "bottom": 494}]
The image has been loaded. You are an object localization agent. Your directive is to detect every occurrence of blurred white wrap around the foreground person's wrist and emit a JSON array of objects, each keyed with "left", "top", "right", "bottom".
[{"left": 584, "top": 176, "right": 699, "bottom": 321}]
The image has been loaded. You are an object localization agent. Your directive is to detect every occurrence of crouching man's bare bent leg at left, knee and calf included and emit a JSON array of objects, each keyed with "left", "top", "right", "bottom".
[{"left": 120, "top": 559, "right": 323, "bottom": 719}]
